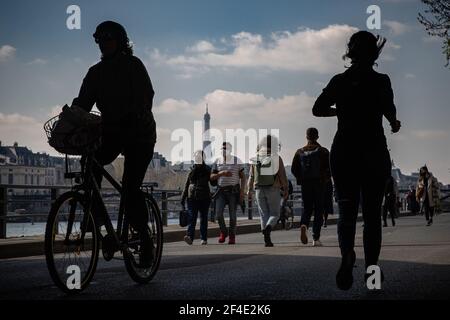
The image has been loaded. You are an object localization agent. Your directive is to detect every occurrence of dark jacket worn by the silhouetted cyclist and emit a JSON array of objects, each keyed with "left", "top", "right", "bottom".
[{"left": 72, "top": 53, "right": 156, "bottom": 143}]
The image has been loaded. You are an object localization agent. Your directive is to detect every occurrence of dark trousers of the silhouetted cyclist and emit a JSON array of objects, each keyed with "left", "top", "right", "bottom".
[{"left": 92, "top": 135, "right": 155, "bottom": 230}]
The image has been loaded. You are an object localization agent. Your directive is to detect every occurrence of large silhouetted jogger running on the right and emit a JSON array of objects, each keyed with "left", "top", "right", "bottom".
[{"left": 313, "top": 31, "right": 401, "bottom": 290}]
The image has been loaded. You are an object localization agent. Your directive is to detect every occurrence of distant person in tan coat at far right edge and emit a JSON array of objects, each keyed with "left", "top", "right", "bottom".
[{"left": 416, "top": 166, "right": 440, "bottom": 226}]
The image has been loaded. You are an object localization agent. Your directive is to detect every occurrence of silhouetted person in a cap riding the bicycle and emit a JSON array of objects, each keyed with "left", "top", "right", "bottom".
[{"left": 72, "top": 21, "right": 156, "bottom": 267}]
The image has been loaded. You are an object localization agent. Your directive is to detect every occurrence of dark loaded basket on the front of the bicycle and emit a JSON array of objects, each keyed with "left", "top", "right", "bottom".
[{"left": 44, "top": 105, "right": 101, "bottom": 155}]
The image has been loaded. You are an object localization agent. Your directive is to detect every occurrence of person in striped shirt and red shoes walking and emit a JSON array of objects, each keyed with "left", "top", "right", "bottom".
[{"left": 211, "top": 142, "right": 246, "bottom": 244}]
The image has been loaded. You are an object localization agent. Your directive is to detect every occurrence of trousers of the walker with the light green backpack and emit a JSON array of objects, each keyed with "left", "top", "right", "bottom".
[{"left": 256, "top": 186, "right": 281, "bottom": 230}]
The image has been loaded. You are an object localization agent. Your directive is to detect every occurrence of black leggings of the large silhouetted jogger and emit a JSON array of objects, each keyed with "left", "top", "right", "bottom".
[{"left": 330, "top": 143, "right": 391, "bottom": 266}]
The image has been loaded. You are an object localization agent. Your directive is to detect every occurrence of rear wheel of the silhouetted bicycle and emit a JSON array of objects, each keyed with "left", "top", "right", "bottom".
[{"left": 123, "top": 194, "right": 163, "bottom": 284}]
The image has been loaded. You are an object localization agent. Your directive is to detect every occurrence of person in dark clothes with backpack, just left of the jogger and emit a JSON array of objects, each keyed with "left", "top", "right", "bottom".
[{"left": 291, "top": 128, "right": 331, "bottom": 247}]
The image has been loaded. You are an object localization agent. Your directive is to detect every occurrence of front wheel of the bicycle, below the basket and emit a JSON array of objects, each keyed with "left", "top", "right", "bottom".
[{"left": 45, "top": 191, "right": 99, "bottom": 293}]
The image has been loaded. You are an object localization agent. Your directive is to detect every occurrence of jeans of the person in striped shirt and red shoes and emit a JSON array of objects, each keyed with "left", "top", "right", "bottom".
[{"left": 216, "top": 191, "right": 240, "bottom": 236}]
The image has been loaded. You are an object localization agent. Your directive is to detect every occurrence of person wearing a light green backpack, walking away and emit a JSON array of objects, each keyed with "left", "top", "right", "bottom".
[{"left": 247, "top": 135, "right": 289, "bottom": 247}]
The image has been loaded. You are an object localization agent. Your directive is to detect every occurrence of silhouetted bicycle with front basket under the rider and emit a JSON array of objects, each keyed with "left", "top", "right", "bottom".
[{"left": 45, "top": 117, "right": 163, "bottom": 293}]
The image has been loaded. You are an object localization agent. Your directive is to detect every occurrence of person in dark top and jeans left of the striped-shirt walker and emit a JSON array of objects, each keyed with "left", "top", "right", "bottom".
[{"left": 181, "top": 150, "right": 211, "bottom": 245}]
